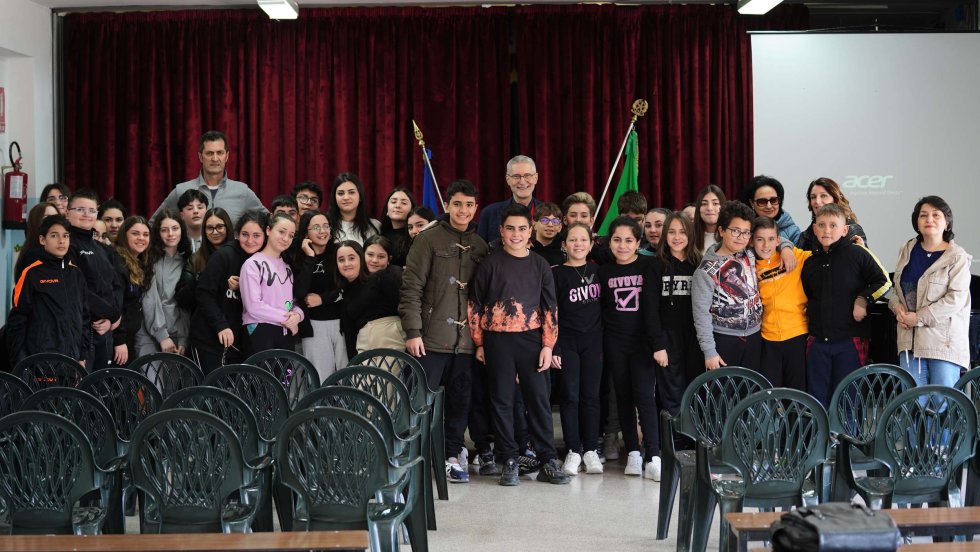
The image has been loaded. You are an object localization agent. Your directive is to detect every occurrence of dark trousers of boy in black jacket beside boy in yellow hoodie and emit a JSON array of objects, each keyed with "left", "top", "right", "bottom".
[{"left": 806, "top": 336, "right": 868, "bottom": 408}]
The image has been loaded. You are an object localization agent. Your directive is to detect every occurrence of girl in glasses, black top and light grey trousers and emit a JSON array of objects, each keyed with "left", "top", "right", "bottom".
[{"left": 293, "top": 209, "right": 347, "bottom": 381}]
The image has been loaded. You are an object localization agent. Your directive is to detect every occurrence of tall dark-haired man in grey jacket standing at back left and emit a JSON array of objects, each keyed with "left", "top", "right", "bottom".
[{"left": 150, "top": 130, "right": 269, "bottom": 224}]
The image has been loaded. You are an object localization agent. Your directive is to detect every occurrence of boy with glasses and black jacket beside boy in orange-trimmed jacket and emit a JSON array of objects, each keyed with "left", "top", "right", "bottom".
[{"left": 67, "top": 189, "right": 123, "bottom": 370}]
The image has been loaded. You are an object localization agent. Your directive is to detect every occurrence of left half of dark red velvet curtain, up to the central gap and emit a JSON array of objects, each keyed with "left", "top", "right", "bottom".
[{"left": 63, "top": 8, "right": 511, "bottom": 213}]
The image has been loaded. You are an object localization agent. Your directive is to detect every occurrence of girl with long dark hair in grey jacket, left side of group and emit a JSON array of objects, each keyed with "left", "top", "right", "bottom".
[{"left": 136, "top": 210, "right": 191, "bottom": 356}]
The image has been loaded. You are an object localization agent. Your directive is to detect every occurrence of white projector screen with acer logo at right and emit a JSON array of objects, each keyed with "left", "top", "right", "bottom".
[{"left": 752, "top": 33, "right": 980, "bottom": 274}]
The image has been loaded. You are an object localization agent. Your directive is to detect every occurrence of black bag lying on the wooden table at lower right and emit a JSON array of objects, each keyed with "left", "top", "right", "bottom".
[{"left": 769, "top": 502, "right": 902, "bottom": 552}]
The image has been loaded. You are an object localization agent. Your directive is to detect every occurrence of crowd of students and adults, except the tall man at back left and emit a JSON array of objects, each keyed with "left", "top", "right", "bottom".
[{"left": 6, "top": 141, "right": 971, "bottom": 492}]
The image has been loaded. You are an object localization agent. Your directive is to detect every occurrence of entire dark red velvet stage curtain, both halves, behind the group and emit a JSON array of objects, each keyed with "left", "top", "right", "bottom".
[{"left": 62, "top": 5, "right": 806, "bottom": 219}]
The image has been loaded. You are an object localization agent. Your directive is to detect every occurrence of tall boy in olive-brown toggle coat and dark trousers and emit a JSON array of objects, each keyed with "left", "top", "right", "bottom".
[{"left": 398, "top": 180, "right": 488, "bottom": 483}]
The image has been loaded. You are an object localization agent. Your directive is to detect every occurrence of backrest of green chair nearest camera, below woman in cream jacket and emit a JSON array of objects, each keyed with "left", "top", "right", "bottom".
[{"left": 874, "top": 385, "right": 977, "bottom": 495}]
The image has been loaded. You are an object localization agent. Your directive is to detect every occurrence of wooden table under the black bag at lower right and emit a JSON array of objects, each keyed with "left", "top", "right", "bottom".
[{"left": 725, "top": 506, "right": 980, "bottom": 552}]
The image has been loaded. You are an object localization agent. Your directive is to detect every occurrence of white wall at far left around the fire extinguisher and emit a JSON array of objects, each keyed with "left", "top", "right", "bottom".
[{"left": 0, "top": 0, "right": 54, "bottom": 323}]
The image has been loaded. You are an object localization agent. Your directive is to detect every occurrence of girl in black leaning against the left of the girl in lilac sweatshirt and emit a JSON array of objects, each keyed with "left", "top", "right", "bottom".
[{"left": 190, "top": 211, "right": 268, "bottom": 374}]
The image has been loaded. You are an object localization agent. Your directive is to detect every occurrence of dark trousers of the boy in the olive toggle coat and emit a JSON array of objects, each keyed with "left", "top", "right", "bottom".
[{"left": 419, "top": 352, "right": 475, "bottom": 458}]
